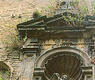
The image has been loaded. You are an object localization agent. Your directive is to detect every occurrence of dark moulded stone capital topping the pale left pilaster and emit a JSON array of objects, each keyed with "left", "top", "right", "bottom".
[{"left": 22, "top": 38, "right": 40, "bottom": 56}]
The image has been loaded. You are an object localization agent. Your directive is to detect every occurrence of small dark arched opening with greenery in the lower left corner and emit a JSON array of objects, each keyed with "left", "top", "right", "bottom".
[{"left": 0, "top": 61, "right": 11, "bottom": 80}]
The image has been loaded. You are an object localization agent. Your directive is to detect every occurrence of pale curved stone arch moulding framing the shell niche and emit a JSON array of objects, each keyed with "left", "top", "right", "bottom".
[{"left": 35, "top": 47, "right": 91, "bottom": 68}]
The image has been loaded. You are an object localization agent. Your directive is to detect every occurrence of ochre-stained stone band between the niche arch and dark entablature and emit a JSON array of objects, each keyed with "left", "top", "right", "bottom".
[{"left": 41, "top": 39, "right": 88, "bottom": 53}]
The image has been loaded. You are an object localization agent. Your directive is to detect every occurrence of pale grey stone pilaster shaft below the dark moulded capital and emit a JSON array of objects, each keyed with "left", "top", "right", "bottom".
[{"left": 17, "top": 55, "right": 36, "bottom": 80}]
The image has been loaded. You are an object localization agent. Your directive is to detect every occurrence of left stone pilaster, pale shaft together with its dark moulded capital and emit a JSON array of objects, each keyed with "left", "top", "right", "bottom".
[{"left": 18, "top": 39, "right": 39, "bottom": 80}]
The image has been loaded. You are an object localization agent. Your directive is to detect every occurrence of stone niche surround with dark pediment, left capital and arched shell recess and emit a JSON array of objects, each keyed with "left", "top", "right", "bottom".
[{"left": 17, "top": 12, "right": 95, "bottom": 80}]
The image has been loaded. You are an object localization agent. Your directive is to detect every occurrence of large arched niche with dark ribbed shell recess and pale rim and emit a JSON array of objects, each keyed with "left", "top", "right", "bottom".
[{"left": 34, "top": 47, "right": 91, "bottom": 80}]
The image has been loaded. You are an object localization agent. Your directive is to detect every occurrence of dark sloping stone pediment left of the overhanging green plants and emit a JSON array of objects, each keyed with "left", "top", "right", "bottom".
[{"left": 17, "top": 12, "right": 84, "bottom": 30}]
